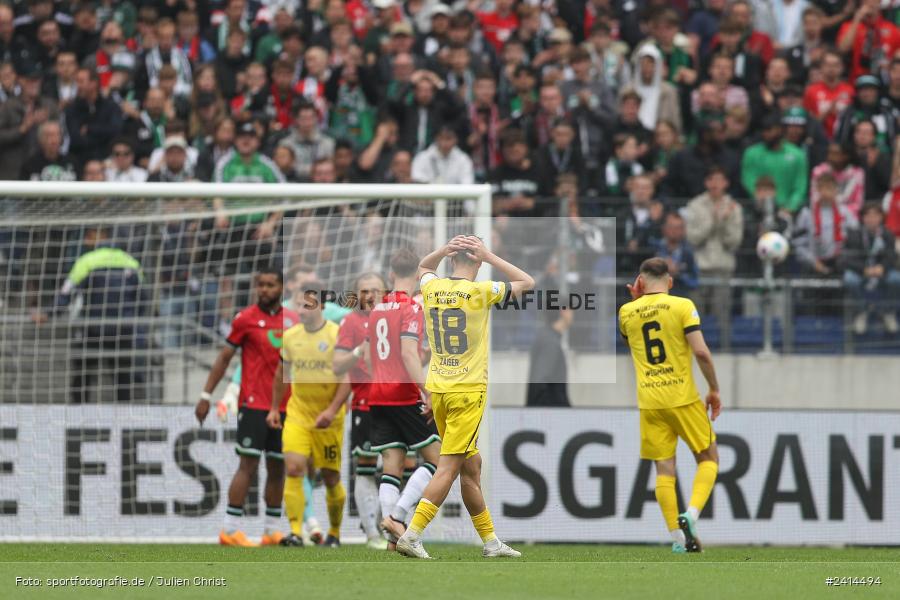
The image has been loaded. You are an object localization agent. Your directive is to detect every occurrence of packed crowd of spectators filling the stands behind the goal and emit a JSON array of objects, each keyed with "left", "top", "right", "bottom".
[{"left": 0, "top": 0, "right": 900, "bottom": 334}]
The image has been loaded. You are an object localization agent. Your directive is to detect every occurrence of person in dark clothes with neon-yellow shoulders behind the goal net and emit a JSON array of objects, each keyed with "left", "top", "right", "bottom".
[{"left": 32, "top": 227, "right": 149, "bottom": 404}]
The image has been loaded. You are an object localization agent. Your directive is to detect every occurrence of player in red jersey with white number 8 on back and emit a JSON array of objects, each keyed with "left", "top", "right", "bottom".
[{"left": 368, "top": 250, "right": 441, "bottom": 543}]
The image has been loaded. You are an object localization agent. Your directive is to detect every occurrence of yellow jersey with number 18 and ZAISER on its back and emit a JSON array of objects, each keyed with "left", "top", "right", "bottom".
[{"left": 420, "top": 273, "right": 510, "bottom": 393}]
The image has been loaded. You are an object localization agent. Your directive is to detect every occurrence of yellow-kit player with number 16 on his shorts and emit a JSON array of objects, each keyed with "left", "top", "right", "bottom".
[{"left": 266, "top": 281, "right": 350, "bottom": 547}]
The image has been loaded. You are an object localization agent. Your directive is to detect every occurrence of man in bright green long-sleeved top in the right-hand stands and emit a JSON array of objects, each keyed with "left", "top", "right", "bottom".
[{"left": 741, "top": 114, "right": 809, "bottom": 212}]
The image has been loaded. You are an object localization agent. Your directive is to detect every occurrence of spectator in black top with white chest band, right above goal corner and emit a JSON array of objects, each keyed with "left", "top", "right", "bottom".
[{"left": 488, "top": 129, "right": 544, "bottom": 216}]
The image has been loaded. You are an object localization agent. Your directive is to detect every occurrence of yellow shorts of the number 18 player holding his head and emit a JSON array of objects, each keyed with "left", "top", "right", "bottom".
[{"left": 431, "top": 392, "right": 487, "bottom": 458}]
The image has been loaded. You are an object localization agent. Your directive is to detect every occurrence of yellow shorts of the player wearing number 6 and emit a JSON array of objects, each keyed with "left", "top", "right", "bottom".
[{"left": 641, "top": 400, "right": 716, "bottom": 460}]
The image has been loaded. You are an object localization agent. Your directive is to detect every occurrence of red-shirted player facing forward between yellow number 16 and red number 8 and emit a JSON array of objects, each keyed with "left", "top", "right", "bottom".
[{"left": 333, "top": 273, "right": 387, "bottom": 550}]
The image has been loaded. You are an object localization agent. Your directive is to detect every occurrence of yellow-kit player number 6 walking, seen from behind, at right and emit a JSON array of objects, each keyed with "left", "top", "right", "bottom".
[{"left": 619, "top": 258, "right": 722, "bottom": 552}]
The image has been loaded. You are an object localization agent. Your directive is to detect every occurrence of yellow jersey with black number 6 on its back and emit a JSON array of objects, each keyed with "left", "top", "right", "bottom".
[{"left": 619, "top": 292, "right": 700, "bottom": 409}]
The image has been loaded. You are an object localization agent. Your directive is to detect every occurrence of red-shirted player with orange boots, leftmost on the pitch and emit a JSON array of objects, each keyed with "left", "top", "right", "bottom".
[{"left": 194, "top": 267, "right": 299, "bottom": 546}]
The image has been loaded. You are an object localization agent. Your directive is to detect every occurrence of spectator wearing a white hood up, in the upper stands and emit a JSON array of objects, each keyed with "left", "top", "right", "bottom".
[{"left": 627, "top": 44, "right": 681, "bottom": 131}]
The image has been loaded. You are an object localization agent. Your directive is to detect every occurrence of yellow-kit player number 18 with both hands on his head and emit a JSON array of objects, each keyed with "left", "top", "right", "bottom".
[{"left": 397, "top": 236, "right": 534, "bottom": 558}]
